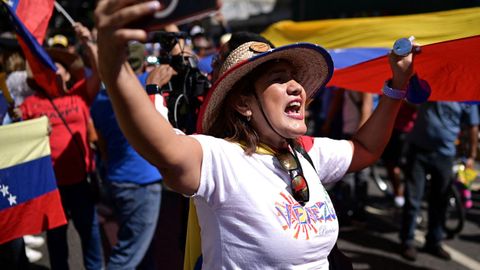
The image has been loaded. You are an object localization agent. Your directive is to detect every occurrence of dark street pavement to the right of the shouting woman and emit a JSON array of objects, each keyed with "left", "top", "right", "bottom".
[{"left": 338, "top": 175, "right": 480, "bottom": 270}]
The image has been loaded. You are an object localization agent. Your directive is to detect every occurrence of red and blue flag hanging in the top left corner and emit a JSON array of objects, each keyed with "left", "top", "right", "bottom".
[{"left": 0, "top": 0, "right": 60, "bottom": 95}]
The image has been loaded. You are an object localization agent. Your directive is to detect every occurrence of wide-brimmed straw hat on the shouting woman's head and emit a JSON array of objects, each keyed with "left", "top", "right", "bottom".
[{"left": 197, "top": 41, "right": 333, "bottom": 133}]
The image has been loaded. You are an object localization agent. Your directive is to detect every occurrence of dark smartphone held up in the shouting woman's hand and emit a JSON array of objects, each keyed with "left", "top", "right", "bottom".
[{"left": 130, "top": 0, "right": 221, "bottom": 31}]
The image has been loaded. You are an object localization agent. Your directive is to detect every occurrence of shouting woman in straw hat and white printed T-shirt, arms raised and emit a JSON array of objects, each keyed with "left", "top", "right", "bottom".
[{"left": 95, "top": 0, "right": 414, "bottom": 269}]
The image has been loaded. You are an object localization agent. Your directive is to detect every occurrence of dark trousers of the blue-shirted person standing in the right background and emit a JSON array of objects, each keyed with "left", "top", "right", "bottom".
[{"left": 400, "top": 146, "right": 454, "bottom": 246}]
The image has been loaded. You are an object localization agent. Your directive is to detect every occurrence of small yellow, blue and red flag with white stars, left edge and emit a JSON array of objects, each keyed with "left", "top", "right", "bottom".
[{"left": 0, "top": 117, "right": 66, "bottom": 244}]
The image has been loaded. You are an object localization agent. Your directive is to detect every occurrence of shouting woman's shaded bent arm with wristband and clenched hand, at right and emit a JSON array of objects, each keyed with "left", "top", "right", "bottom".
[{"left": 349, "top": 49, "right": 416, "bottom": 171}]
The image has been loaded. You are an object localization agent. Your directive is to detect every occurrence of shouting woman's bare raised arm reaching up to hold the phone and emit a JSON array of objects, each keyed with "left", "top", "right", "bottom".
[{"left": 95, "top": 0, "right": 203, "bottom": 194}]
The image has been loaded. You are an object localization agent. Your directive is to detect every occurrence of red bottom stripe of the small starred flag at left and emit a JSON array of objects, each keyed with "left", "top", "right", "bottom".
[{"left": 0, "top": 189, "right": 67, "bottom": 244}]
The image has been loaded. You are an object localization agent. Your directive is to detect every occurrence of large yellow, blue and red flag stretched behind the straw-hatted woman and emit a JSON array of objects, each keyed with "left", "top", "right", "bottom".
[{"left": 263, "top": 7, "right": 480, "bottom": 101}]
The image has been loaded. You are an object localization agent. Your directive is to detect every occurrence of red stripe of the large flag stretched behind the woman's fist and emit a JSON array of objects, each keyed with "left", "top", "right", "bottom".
[{"left": 328, "top": 36, "right": 480, "bottom": 101}]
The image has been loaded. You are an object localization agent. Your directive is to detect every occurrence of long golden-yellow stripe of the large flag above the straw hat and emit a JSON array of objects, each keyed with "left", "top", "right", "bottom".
[{"left": 262, "top": 7, "right": 480, "bottom": 49}]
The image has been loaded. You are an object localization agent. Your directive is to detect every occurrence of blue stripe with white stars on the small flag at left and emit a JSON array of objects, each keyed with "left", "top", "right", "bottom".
[{"left": 0, "top": 156, "right": 57, "bottom": 211}]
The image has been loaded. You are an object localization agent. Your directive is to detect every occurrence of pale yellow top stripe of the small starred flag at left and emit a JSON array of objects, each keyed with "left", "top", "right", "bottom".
[{"left": 0, "top": 116, "right": 50, "bottom": 169}]
